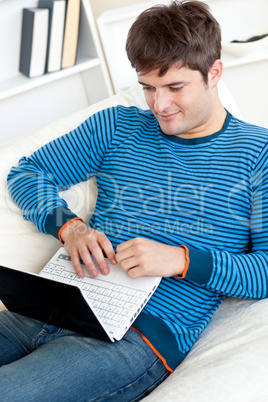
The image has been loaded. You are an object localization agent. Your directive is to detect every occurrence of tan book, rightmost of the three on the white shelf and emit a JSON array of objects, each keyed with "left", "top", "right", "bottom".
[{"left": 61, "top": 0, "right": 80, "bottom": 68}]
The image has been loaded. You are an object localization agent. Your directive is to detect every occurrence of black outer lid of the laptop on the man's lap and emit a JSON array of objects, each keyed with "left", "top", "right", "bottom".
[{"left": 0, "top": 266, "right": 110, "bottom": 340}]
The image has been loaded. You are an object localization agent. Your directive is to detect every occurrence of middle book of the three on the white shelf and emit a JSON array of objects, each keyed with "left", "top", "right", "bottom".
[{"left": 38, "top": 0, "right": 66, "bottom": 73}]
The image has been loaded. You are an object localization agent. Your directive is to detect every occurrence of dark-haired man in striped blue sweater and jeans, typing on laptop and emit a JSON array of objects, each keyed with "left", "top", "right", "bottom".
[{"left": 0, "top": 1, "right": 268, "bottom": 401}]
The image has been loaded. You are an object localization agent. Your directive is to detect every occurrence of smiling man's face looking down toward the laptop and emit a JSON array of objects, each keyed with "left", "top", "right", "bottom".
[{"left": 138, "top": 66, "right": 218, "bottom": 138}]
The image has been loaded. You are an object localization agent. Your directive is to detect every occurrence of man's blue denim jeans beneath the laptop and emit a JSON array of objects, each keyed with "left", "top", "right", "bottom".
[{"left": 0, "top": 311, "right": 169, "bottom": 402}]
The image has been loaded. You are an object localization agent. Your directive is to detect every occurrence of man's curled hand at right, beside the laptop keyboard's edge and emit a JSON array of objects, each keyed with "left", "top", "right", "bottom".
[{"left": 116, "top": 237, "right": 186, "bottom": 278}]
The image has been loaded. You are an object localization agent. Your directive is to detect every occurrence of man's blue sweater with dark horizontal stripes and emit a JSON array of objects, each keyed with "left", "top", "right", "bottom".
[{"left": 8, "top": 106, "right": 268, "bottom": 371}]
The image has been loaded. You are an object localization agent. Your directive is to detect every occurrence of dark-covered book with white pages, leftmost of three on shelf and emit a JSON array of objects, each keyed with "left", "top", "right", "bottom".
[{"left": 19, "top": 8, "right": 49, "bottom": 77}]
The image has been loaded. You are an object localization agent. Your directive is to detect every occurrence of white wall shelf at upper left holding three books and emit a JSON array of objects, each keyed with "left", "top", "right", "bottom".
[{"left": 0, "top": 0, "right": 113, "bottom": 142}]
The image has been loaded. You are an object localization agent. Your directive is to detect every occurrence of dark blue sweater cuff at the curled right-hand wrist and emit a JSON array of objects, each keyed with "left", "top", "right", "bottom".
[{"left": 185, "top": 248, "right": 213, "bottom": 285}]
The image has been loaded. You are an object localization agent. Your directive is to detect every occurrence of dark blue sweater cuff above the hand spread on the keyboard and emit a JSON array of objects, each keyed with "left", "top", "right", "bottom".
[{"left": 45, "top": 206, "right": 77, "bottom": 240}]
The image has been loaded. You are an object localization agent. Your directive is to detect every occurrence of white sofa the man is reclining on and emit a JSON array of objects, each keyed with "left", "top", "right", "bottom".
[{"left": 0, "top": 86, "right": 268, "bottom": 402}]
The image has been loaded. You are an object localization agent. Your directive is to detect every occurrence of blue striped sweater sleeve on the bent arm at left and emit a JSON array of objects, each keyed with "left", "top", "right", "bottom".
[{"left": 8, "top": 109, "right": 115, "bottom": 238}]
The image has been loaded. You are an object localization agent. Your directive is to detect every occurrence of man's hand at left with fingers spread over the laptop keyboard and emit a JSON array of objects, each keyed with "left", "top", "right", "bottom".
[{"left": 61, "top": 220, "right": 117, "bottom": 277}]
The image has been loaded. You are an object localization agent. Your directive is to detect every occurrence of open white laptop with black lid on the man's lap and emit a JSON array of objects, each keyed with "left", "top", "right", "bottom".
[{"left": 0, "top": 247, "right": 161, "bottom": 342}]
